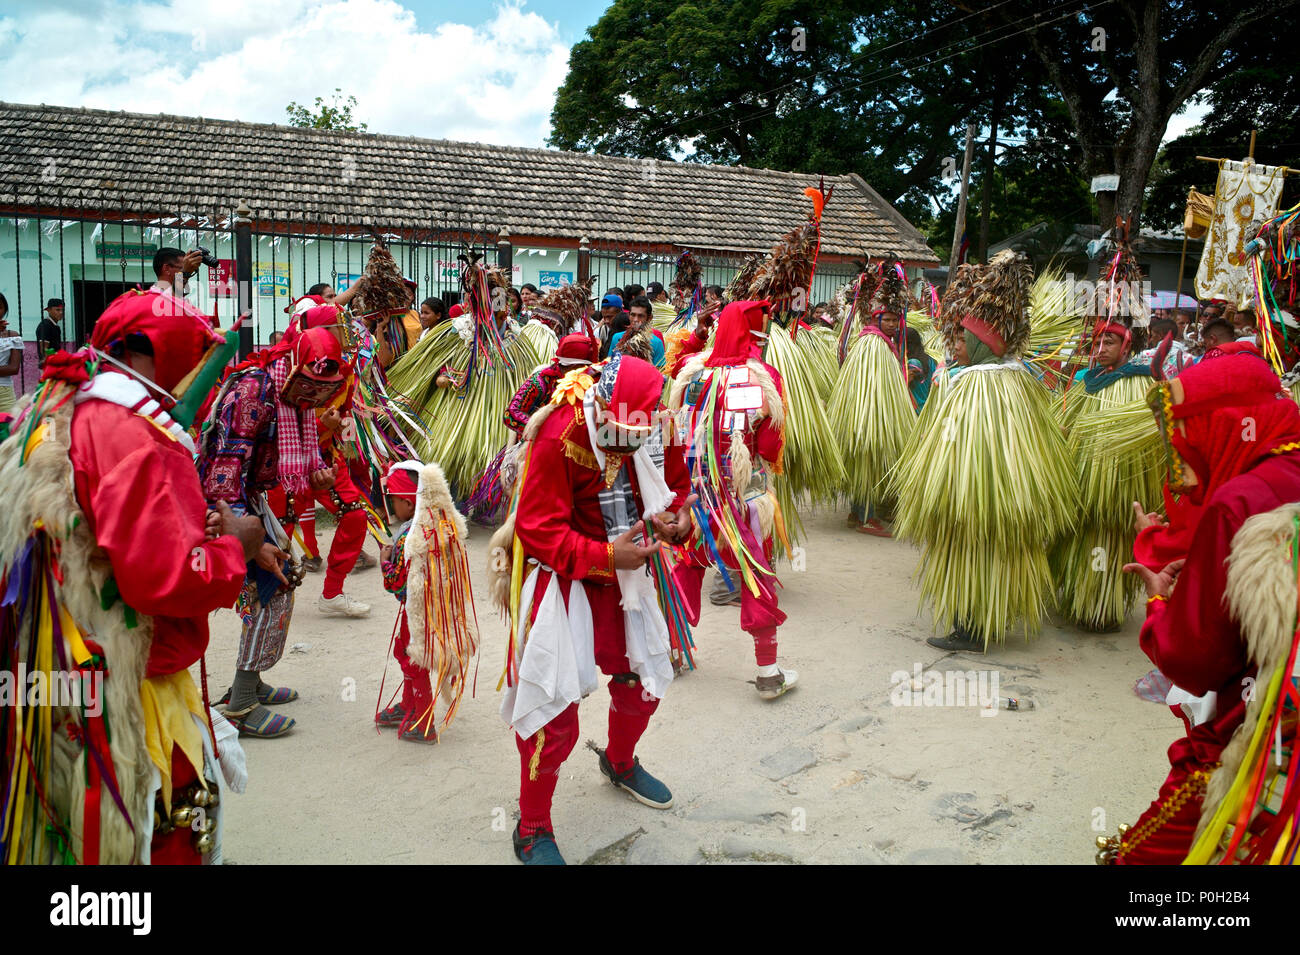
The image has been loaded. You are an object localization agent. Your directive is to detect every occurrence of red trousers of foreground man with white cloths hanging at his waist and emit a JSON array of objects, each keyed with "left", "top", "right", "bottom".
[{"left": 515, "top": 570, "right": 659, "bottom": 835}]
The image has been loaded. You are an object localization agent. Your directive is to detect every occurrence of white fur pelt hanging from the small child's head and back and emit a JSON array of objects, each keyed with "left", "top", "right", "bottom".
[{"left": 403, "top": 464, "right": 478, "bottom": 703}]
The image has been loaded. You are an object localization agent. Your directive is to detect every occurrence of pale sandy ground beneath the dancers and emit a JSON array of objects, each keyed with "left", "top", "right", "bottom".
[{"left": 200, "top": 513, "right": 1180, "bottom": 864}]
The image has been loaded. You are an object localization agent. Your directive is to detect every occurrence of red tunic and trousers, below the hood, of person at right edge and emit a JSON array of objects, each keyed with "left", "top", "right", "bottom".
[{"left": 1119, "top": 453, "right": 1300, "bottom": 864}]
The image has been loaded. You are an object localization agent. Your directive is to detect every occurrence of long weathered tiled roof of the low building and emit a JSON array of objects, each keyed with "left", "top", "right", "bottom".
[{"left": 0, "top": 103, "right": 937, "bottom": 262}]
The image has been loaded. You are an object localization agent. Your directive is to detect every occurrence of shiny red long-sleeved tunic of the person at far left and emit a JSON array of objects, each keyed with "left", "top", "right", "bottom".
[{"left": 70, "top": 400, "right": 246, "bottom": 677}]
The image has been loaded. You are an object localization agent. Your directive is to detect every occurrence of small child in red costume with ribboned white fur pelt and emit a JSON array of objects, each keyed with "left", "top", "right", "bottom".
[{"left": 374, "top": 461, "right": 478, "bottom": 743}]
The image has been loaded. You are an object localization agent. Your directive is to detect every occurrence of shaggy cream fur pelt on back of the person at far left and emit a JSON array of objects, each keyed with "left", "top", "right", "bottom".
[{"left": 0, "top": 396, "right": 153, "bottom": 865}]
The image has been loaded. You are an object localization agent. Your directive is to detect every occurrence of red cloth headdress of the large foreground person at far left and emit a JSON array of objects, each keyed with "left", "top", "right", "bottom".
[{"left": 90, "top": 290, "right": 225, "bottom": 391}]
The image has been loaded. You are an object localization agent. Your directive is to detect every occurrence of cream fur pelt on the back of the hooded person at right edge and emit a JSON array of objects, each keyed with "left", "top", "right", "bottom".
[{"left": 1196, "top": 504, "right": 1300, "bottom": 837}]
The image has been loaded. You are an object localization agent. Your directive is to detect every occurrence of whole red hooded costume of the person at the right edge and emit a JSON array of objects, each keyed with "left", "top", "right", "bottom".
[{"left": 1117, "top": 353, "right": 1300, "bottom": 865}]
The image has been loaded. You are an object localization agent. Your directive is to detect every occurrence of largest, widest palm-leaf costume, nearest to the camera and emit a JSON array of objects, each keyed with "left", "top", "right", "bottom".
[{"left": 891, "top": 366, "right": 1076, "bottom": 646}]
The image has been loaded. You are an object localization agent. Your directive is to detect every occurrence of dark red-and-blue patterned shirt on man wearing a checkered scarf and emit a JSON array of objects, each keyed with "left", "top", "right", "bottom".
[{"left": 198, "top": 368, "right": 280, "bottom": 515}]
